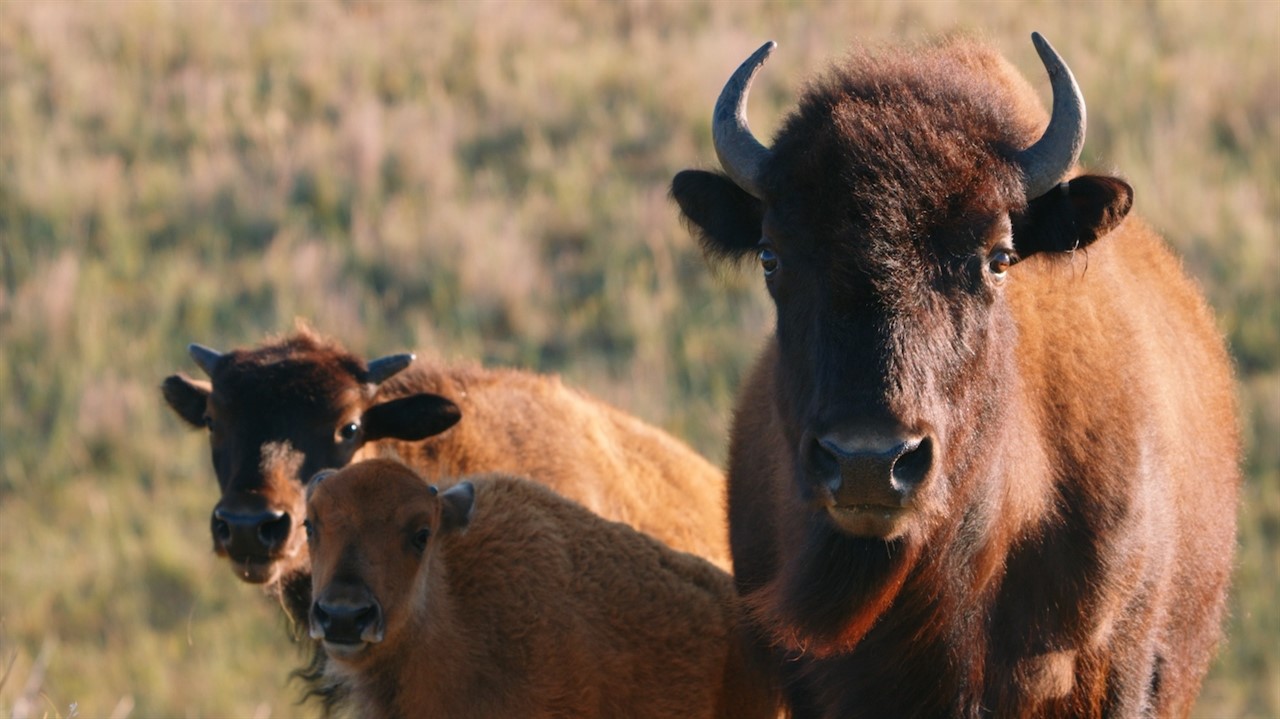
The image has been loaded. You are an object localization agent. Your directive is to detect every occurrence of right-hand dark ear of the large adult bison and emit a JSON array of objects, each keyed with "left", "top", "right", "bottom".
[{"left": 1014, "top": 175, "right": 1133, "bottom": 257}]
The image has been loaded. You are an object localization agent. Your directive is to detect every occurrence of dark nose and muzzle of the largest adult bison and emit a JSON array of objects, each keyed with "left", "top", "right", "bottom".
[{"left": 808, "top": 432, "right": 933, "bottom": 507}]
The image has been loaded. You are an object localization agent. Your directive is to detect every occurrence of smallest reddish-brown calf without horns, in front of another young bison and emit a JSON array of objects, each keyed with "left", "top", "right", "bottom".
[{"left": 306, "top": 459, "right": 777, "bottom": 719}]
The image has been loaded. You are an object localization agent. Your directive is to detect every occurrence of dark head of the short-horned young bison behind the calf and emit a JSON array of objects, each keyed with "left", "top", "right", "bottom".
[{"left": 164, "top": 335, "right": 458, "bottom": 585}]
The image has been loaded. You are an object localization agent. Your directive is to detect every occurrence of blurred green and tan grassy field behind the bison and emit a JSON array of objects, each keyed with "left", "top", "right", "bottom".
[{"left": 0, "top": 0, "right": 1280, "bottom": 716}]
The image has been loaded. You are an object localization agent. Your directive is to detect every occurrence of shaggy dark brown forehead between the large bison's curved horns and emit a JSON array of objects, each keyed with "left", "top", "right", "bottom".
[{"left": 762, "top": 39, "right": 1043, "bottom": 257}]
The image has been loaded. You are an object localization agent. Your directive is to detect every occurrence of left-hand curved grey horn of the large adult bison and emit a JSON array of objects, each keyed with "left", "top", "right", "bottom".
[{"left": 712, "top": 40, "right": 778, "bottom": 198}]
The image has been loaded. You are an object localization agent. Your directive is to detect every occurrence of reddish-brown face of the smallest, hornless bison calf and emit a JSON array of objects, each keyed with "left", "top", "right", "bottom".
[{"left": 306, "top": 459, "right": 475, "bottom": 665}]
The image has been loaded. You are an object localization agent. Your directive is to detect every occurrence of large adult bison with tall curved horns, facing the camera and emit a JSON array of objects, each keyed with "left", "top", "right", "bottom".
[{"left": 672, "top": 35, "right": 1239, "bottom": 719}]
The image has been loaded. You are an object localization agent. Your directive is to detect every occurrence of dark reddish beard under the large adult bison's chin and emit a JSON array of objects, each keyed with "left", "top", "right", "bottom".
[{"left": 745, "top": 521, "right": 920, "bottom": 658}]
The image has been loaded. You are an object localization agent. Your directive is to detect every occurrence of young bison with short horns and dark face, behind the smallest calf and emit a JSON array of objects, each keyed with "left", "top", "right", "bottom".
[{"left": 163, "top": 328, "right": 728, "bottom": 620}]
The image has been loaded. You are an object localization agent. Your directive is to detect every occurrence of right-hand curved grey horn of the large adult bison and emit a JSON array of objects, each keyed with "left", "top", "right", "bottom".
[{"left": 1018, "top": 32, "right": 1085, "bottom": 200}]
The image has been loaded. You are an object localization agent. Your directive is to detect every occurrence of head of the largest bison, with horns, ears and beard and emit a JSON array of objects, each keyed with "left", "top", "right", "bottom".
[{"left": 672, "top": 35, "right": 1132, "bottom": 644}]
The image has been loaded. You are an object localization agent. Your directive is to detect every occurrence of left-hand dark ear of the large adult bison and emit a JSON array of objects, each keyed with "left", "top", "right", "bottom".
[{"left": 671, "top": 170, "right": 764, "bottom": 260}]
